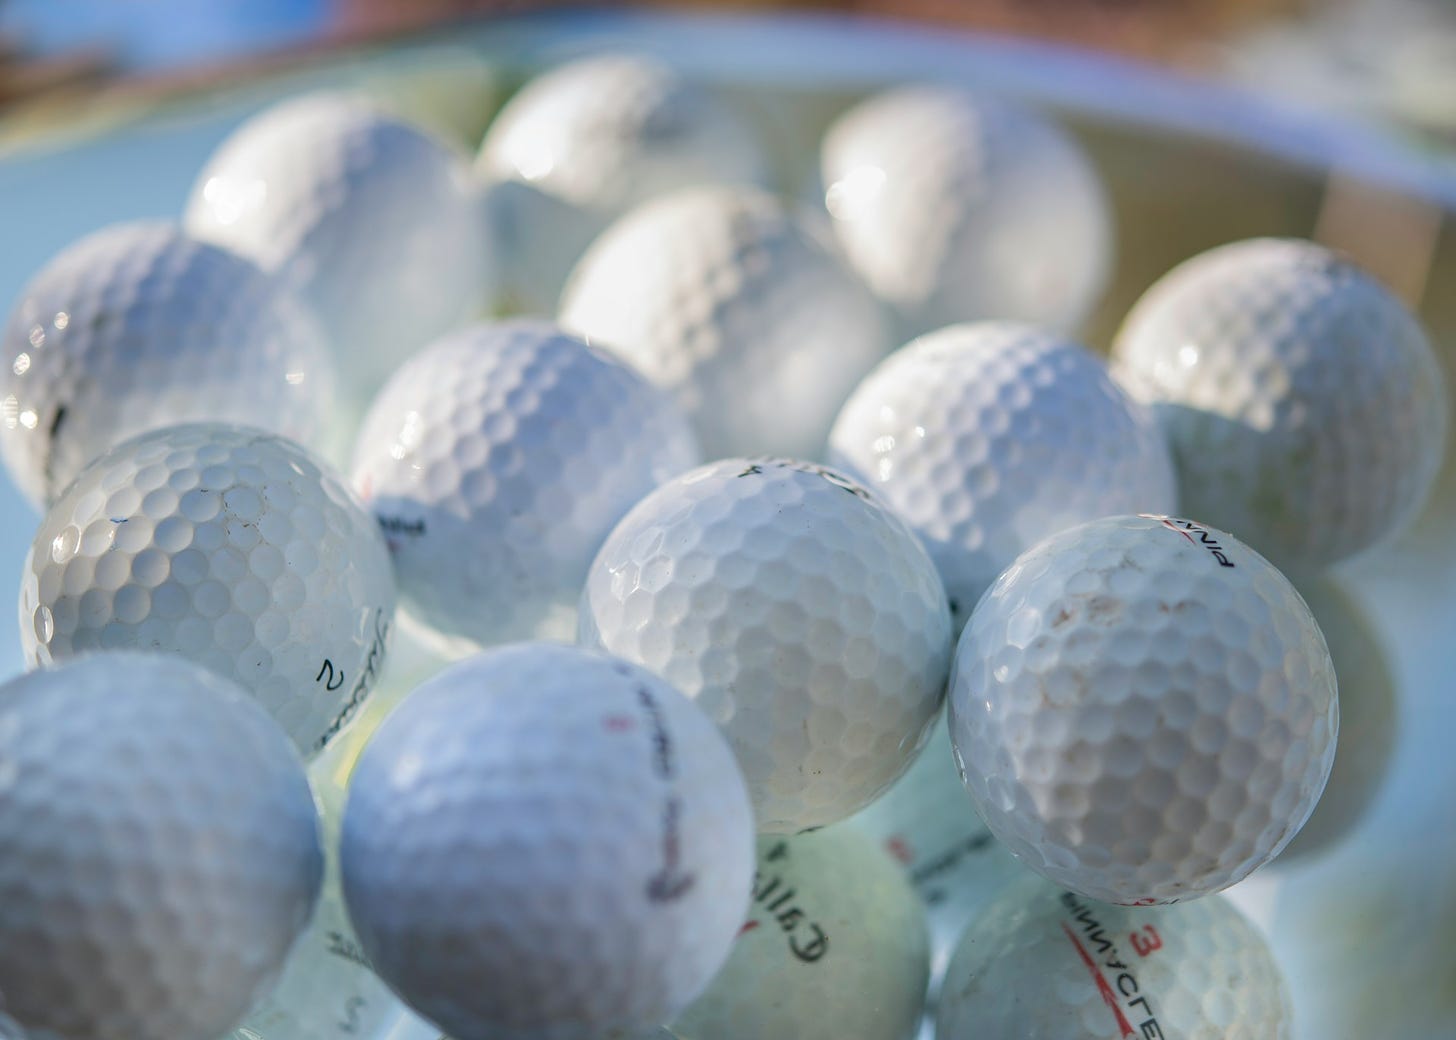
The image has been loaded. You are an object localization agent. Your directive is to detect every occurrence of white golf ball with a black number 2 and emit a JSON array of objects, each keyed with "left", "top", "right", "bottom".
[{"left": 20, "top": 422, "right": 395, "bottom": 755}]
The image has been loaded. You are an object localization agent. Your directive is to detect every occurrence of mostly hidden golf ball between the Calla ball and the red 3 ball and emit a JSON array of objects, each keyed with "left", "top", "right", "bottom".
[{"left": 844, "top": 712, "right": 1029, "bottom": 1005}]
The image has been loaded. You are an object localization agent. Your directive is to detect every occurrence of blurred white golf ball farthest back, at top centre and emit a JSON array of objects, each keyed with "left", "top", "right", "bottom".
[{"left": 476, "top": 54, "right": 769, "bottom": 315}]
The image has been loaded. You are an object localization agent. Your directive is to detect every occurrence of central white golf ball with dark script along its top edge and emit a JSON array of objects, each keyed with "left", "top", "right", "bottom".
[{"left": 581, "top": 459, "right": 951, "bottom": 833}]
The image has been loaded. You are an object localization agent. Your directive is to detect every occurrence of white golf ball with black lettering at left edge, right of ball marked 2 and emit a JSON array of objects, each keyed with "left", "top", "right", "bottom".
[{"left": 354, "top": 322, "right": 700, "bottom": 651}]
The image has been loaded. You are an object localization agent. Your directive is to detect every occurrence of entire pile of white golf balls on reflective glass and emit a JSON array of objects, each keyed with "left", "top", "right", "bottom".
[{"left": 0, "top": 40, "right": 1447, "bottom": 1040}]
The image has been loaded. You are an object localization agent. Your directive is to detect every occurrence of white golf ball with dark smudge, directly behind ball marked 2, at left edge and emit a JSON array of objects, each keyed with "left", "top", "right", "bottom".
[{"left": 0, "top": 223, "right": 333, "bottom": 507}]
